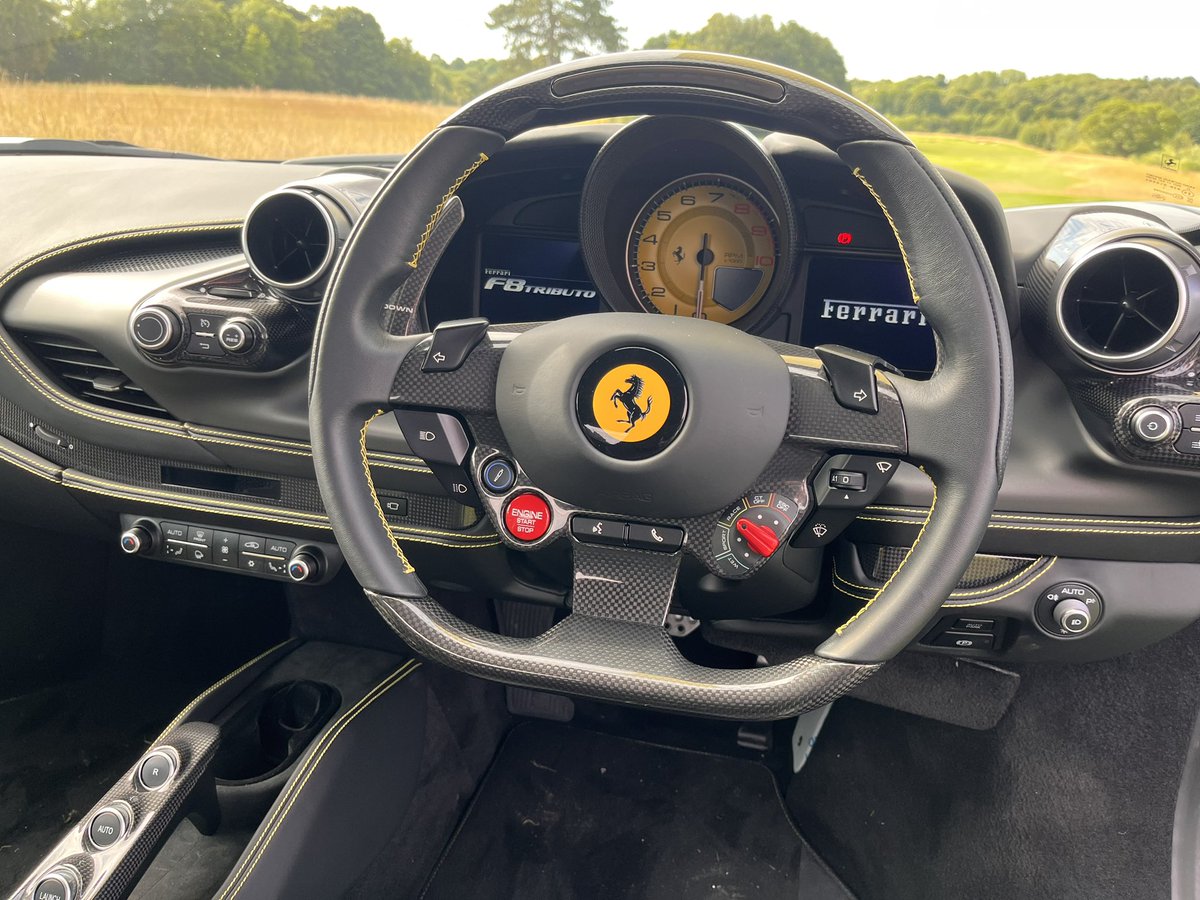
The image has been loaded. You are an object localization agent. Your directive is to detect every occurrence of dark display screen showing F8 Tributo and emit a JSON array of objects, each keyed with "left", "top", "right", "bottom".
[{"left": 479, "top": 233, "right": 601, "bottom": 323}]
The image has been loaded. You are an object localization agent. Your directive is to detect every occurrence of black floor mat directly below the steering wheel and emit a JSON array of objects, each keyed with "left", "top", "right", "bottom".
[{"left": 422, "top": 722, "right": 850, "bottom": 900}]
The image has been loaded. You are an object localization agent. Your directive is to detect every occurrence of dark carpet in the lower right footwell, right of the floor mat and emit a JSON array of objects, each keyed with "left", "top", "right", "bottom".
[{"left": 787, "top": 626, "right": 1200, "bottom": 900}]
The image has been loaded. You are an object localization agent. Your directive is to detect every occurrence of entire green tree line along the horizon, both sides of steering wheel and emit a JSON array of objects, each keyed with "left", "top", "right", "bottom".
[{"left": 0, "top": 0, "right": 1200, "bottom": 156}]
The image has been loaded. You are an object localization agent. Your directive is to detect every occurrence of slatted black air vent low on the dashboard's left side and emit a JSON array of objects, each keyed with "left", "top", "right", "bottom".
[{"left": 22, "top": 334, "right": 172, "bottom": 419}]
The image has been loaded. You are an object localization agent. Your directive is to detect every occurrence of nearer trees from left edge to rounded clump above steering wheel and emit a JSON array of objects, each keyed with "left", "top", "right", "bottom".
[{"left": 0, "top": 0, "right": 846, "bottom": 103}]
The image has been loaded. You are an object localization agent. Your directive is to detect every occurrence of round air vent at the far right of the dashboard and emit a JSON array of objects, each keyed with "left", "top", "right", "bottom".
[{"left": 1057, "top": 238, "right": 1200, "bottom": 372}]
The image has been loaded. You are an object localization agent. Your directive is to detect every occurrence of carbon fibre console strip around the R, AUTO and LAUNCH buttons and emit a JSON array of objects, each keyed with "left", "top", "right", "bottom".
[{"left": 11, "top": 722, "right": 221, "bottom": 900}]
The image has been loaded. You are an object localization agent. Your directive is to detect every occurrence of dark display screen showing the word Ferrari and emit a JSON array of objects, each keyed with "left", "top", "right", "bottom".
[{"left": 800, "top": 256, "right": 937, "bottom": 374}]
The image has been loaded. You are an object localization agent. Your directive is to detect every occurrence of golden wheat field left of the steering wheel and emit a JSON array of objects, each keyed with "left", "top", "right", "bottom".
[{"left": 0, "top": 82, "right": 451, "bottom": 160}]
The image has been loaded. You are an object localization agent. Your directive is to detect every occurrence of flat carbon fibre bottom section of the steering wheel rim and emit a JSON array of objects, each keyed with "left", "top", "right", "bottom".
[{"left": 367, "top": 592, "right": 878, "bottom": 720}]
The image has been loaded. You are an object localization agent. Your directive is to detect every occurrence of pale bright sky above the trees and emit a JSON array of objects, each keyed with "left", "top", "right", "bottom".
[{"left": 360, "top": 0, "right": 1200, "bottom": 80}]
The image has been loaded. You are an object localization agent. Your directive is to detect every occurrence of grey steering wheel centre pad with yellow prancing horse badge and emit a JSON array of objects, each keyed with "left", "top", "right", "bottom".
[{"left": 496, "top": 313, "right": 791, "bottom": 517}]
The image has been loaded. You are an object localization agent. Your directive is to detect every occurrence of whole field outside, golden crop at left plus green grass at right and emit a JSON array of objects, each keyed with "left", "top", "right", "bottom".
[{"left": 0, "top": 82, "right": 1200, "bottom": 206}]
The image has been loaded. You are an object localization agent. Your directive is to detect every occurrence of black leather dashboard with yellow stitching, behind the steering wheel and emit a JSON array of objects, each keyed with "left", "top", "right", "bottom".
[{"left": 0, "top": 126, "right": 1200, "bottom": 658}]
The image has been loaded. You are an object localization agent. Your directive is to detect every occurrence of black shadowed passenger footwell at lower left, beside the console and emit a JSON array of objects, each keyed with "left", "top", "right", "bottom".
[{"left": 0, "top": 559, "right": 287, "bottom": 893}]
